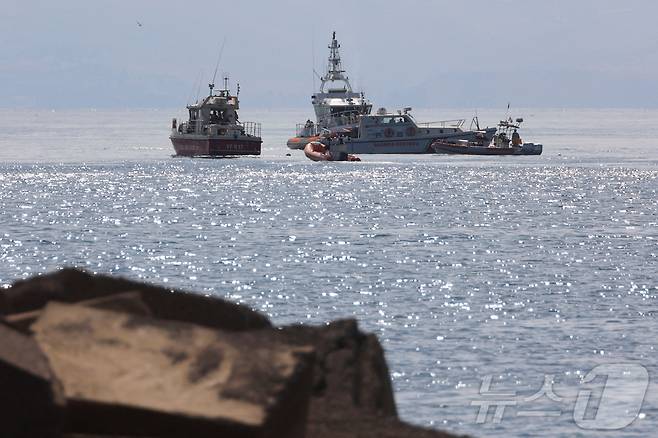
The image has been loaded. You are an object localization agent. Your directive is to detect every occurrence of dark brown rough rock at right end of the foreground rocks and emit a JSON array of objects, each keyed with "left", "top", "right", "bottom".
[{"left": 280, "top": 319, "right": 468, "bottom": 438}]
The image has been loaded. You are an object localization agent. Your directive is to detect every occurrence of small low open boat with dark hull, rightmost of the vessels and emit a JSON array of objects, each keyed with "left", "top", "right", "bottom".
[{"left": 431, "top": 118, "right": 543, "bottom": 155}]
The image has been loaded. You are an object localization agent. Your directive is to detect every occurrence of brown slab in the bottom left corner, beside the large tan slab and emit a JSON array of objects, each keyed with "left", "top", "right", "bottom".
[{"left": 0, "top": 324, "right": 64, "bottom": 438}]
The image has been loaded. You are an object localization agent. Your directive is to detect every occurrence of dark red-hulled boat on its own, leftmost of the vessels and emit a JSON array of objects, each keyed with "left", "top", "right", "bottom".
[{"left": 169, "top": 78, "right": 262, "bottom": 157}]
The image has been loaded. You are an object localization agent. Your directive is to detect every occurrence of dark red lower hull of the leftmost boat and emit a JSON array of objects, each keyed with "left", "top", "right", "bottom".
[{"left": 171, "top": 138, "right": 262, "bottom": 157}]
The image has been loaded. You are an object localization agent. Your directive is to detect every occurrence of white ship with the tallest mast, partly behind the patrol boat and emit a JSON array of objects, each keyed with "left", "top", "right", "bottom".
[{"left": 287, "top": 32, "right": 372, "bottom": 149}]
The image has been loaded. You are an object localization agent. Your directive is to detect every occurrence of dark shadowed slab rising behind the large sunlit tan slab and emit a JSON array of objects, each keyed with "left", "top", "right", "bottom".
[{"left": 0, "top": 269, "right": 271, "bottom": 331}]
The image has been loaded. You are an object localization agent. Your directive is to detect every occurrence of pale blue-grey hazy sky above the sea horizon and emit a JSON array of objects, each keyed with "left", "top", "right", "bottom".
[{"left": 0, "top": 0, "right": 658, "bottom": 108}]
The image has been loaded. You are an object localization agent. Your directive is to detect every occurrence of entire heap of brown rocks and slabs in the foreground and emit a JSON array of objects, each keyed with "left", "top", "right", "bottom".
[{"left": 0, "top": 269, "right": 464, "bottom": 438}]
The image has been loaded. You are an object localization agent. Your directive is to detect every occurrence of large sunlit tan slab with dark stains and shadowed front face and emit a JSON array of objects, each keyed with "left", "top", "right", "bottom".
[{"left": 32, "top": 302, "right": 313, "bottom": 438}]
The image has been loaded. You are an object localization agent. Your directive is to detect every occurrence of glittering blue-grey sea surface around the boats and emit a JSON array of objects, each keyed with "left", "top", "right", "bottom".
[{"left": 0, "top": 110, "right": 658, "bottom": 436}]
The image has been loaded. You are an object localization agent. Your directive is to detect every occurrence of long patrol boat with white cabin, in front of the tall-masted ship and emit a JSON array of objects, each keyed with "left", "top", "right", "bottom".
[{"left": 318, "top": 108, "right": 496, "bottom": 154}]
